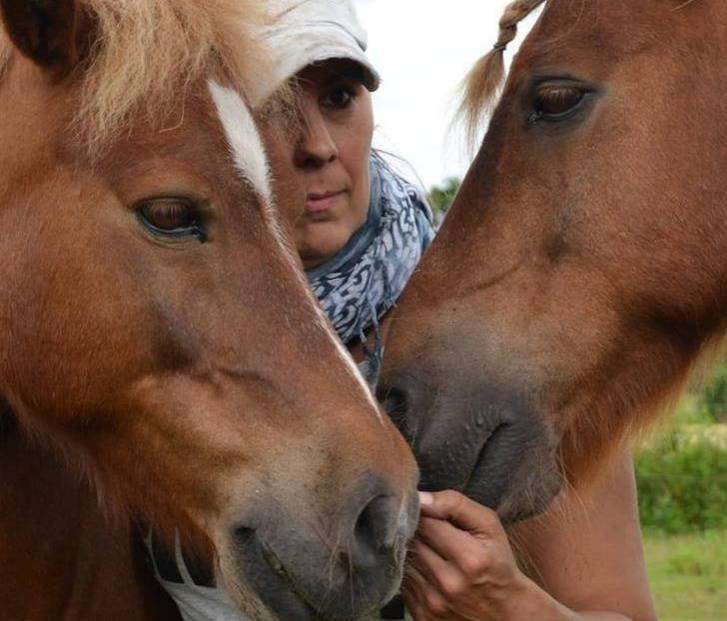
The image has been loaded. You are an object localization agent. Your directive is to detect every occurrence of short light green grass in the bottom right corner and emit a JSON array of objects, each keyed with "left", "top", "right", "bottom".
[{"left": 644, "top": 531, "right": 727, "bottom": 621}]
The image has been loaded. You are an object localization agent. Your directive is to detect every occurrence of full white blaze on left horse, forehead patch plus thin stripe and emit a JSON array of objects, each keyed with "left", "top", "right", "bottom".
[{"left": 208, "top": 80, "right": 383, "bottom": 423}]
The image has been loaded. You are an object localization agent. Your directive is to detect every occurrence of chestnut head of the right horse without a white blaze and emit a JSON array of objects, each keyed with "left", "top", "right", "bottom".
[{"left": 379, "top": 0, "right": 727, "bottom": 520}]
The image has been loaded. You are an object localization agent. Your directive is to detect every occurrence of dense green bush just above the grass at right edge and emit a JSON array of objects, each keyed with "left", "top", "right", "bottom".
[{"left": 636, "top": 432, "right": 727, "bottom": 533}]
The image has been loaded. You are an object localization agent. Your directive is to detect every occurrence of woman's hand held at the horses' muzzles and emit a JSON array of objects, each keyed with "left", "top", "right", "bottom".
[{"left": 404, "top": 491, "right": 563, "bottom": 621}]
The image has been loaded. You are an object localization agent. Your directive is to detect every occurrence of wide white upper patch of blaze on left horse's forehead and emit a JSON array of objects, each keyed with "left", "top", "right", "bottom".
[{"left": 209, "top": 80, "right": 272, "bottom": 205}]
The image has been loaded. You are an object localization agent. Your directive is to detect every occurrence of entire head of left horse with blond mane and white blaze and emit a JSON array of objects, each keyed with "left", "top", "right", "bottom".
[{"left": 0, "top": 0, "right": 417, "bottom": 619}]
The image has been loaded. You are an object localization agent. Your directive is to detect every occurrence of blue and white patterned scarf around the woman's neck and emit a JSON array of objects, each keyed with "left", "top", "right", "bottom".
[{"left": 306, "top": 154, "right": 434, "bottom": 376}]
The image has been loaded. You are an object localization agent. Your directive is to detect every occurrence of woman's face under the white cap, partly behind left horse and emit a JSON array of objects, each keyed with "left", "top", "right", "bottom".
[{"left": 268, "top": 61, "right": 373, "bottom": 269}]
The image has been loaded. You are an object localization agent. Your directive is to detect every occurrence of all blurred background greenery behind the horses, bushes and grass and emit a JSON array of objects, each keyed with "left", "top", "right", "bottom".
[{"left": 428, "top": 178, "right": 727, "bottom": 621}]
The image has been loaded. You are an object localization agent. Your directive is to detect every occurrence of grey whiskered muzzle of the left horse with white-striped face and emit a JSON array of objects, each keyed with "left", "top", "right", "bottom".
[{"left": 222, "top": 475, "right": 419, "bottom": 621}]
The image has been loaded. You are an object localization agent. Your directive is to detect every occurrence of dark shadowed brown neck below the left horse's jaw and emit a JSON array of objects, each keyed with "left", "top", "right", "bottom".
[{"left": 0, "top": 413, "right": 179, "bottom": 621}]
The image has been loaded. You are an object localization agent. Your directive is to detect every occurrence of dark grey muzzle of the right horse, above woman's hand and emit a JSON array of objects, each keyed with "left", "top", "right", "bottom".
[{"left": 378, "top": 365, "right": 562, "bottom": 523}]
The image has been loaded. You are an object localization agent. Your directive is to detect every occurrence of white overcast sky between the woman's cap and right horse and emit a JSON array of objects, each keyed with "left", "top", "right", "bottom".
[{"left": 355, "top": 0, "right": 535, "bottom": 188}]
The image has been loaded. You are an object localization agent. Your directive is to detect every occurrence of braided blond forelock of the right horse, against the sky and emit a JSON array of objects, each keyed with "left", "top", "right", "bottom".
[{"left": 455, "top": 0, "right": 546, "bottom": 146}]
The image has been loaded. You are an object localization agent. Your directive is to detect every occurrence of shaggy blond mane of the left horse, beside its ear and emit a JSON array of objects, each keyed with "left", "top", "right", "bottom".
[{"left": 0, "top": 0, "right": 268, "bottom": 150}]
